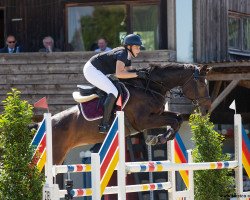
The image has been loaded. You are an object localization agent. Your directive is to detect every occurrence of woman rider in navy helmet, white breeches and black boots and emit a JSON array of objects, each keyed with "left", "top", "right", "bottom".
[{"left": 83, "top": 34, "right": 146, "bottom": 133}]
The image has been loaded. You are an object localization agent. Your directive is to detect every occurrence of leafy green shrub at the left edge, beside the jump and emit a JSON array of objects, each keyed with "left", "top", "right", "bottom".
[{"left": 0, "top": 89, "right": 44, "bottom": 200}]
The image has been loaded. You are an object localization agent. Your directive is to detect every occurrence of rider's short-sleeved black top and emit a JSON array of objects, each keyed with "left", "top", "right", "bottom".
[{"left": 90, "top": 47, "right": 131, "bottom": 75}]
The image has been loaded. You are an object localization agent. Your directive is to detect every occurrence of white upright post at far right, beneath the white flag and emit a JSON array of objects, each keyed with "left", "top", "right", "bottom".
[{"left": 234, "top": 114, "right": 243, "bottom": 199}]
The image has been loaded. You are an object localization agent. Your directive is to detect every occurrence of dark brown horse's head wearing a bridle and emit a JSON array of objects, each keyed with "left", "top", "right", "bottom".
[{"left": 182, "top": 66, "right": 211, "bottom": 112}]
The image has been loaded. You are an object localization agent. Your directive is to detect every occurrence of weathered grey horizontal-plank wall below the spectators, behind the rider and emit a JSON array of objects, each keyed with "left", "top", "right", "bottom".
[{"left": 0, "top": 51, "right": 176, "bottom": 114}]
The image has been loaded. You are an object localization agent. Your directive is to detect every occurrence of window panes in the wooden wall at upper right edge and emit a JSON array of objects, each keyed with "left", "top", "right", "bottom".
[{"left": 228, "top": 13, "right": 250, "bottom": 54}]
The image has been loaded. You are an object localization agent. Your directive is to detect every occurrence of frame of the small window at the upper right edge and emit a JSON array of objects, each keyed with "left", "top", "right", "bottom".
[{"left": 227, "top": 11, "right": 250, "bottom": 56}]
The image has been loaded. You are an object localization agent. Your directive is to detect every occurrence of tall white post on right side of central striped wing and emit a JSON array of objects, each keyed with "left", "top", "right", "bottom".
[{"left": 117, "top": 111, "right": 126, "bottom": 200}]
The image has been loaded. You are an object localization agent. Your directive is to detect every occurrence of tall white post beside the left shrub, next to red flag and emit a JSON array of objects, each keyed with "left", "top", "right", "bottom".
[{"left": 44, "top": 113, "right": 53, "bottom": 187}]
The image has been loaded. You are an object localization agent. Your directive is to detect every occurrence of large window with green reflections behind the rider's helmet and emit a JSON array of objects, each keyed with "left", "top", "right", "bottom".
[{"left": 67, "top": 3, "right": 159, "bottom": 51}]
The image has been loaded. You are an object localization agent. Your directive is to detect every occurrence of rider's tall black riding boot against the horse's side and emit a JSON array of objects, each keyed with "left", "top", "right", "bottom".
[{"left": 99, "top": 93, "right": 116, "bottom": 133}]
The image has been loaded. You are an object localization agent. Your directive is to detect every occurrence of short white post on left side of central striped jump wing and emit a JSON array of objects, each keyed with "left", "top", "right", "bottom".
[{"left": 91, "top": 153, "right": 101, "bottom": 200}]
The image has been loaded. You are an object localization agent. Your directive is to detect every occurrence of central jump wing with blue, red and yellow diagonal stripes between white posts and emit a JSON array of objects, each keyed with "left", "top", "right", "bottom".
[{"left": 91, "top": 111, "right": 126, "bottom": 200}]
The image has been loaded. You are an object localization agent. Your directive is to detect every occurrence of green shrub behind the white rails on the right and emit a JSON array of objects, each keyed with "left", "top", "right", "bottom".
[{"left": 189, "top": 113, "right": 234, "bottom": 200}]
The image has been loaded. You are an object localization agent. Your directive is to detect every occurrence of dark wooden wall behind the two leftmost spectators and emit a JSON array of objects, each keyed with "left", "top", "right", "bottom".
[{"left": 0, "top": 0, "right": 65, "bottom": 52}]
